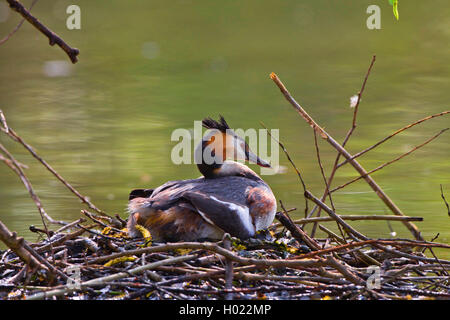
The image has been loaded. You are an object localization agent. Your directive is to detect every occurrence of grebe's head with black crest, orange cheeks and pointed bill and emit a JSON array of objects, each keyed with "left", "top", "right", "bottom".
[{"left": 195, "top": 116, "right": 270, "bottom": 177}]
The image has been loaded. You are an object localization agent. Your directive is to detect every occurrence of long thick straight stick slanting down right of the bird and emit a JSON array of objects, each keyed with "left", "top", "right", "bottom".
[{"left": 270, "top": 73, "right": 422, "bottom": 240}]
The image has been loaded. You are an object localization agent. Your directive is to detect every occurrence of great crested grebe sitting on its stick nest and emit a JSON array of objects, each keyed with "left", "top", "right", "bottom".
[{"left": 127, "top": 116, "right": 277, "bottom": 241}]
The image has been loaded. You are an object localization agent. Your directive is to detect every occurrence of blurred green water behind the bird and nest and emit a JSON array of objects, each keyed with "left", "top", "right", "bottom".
[{"left": 0, "top": 0, "right": 450, "bottom": 252}]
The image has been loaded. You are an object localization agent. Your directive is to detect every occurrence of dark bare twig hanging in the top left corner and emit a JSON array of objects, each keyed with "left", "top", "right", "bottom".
[{"left": 6, "top": 0, "right": 80, "bottom": 63}]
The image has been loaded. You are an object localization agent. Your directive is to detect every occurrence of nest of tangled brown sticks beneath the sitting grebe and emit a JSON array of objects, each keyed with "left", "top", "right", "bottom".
[{"left": 0, "top": 57, "right": 450, "bottom": 300}]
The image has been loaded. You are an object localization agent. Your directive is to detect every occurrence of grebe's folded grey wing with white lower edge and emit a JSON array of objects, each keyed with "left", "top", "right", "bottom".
[{"left": 183, "top": 191, "right": 255, "bottom": 239}]
